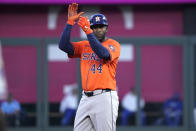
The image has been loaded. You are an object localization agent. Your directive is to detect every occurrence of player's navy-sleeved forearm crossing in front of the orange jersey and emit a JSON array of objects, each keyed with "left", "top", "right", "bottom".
[{"left": 87, "top": 33, "right": 110, "bottom": 60}]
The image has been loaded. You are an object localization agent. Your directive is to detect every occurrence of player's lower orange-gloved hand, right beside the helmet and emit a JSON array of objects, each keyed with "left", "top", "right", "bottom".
[{"left": 78, "top": 16, "right": 93, "bottom": 35}]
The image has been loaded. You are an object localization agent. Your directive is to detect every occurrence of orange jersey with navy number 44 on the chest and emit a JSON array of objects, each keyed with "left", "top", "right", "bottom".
[{"left": 69, "top": 39, "right": 120, "bottom": 91}]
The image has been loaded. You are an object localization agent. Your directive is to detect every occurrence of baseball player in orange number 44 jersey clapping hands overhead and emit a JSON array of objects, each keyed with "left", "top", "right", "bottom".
[{"left": 59, "top": 3, "right": 120, "bottom": 131}]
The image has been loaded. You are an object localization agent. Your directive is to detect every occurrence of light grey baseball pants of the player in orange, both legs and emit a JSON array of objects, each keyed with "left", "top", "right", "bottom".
[{"left": 74, "top": 91, "right": 119, "bottom": 131}]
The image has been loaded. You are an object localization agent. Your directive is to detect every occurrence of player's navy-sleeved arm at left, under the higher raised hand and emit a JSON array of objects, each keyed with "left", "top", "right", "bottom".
[{"left": 59, "top": 24, "right": 74, "bottom": 55}]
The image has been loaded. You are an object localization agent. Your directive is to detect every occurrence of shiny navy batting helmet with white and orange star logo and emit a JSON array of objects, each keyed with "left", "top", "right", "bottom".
[{"left": 90, "top": 14, "right": 108, "bottom": 26}]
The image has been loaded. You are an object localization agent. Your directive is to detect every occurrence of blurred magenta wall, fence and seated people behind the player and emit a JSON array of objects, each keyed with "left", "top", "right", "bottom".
[{"left": 0, "top": 0, "right": 196, "bottom": 131}]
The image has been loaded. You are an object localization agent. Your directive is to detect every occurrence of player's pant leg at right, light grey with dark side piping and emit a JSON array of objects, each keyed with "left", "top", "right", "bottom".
[{"left": 90, "top": 91, "right": 119, "bottom": 131}]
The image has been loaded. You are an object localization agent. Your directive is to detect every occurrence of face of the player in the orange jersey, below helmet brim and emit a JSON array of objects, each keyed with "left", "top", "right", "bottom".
[{"left": 92, "top": 25, "right": 107, "bottom": 42}]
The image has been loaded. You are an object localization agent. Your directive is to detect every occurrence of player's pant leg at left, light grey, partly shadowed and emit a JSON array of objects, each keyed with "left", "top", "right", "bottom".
[{"left": 74, "top": 95, "right": 95, "bottom": 131}]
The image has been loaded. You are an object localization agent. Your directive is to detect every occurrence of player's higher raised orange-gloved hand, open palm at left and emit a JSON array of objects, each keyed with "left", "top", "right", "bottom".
[{"left": 67, "top": 3, "right": 84, "bottom": 25}]
